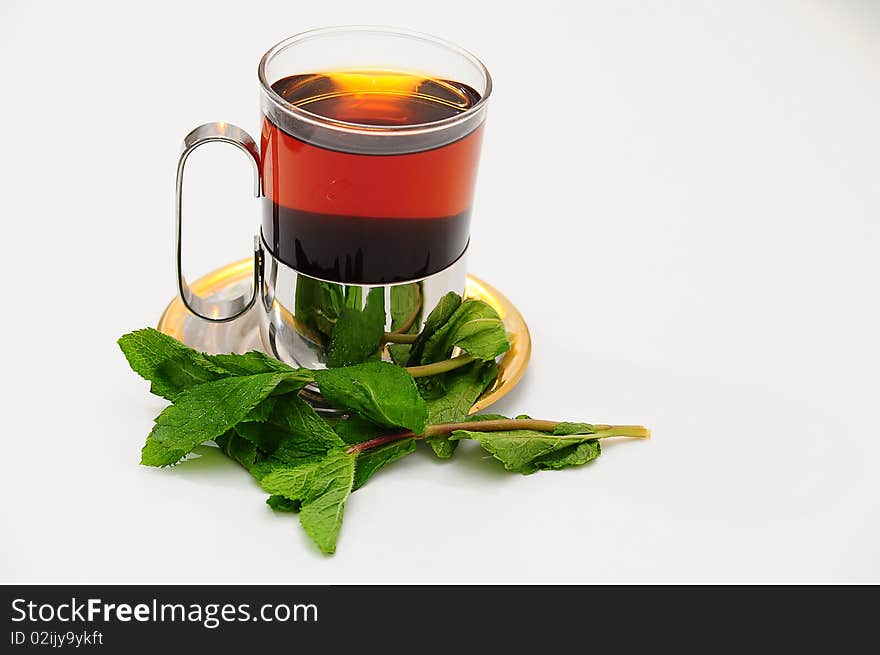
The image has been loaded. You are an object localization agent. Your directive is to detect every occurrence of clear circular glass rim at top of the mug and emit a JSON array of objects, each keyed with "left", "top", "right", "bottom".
[{"left": 257, "top": 25, "right": 492, "bottom": 135}]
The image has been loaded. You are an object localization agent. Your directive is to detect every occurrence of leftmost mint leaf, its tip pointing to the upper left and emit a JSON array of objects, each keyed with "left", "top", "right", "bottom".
[{"left": 117, "top": 328, "right": 228, "bottom": 400}]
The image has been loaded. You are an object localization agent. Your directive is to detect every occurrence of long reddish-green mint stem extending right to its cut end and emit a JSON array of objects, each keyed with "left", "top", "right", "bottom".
[{"left": 345, "top": 418, "right": 651, "bottom": 454}]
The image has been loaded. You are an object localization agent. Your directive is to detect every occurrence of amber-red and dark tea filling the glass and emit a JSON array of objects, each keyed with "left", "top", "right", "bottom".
[{"left": 262, "top": 70, "right": 482, "bottom": 284}]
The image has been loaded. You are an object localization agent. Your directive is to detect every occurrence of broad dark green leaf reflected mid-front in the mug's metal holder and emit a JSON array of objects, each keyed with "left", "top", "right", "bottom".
[{"left": 327, "top": 287, "right": 385, "bottom": 368}]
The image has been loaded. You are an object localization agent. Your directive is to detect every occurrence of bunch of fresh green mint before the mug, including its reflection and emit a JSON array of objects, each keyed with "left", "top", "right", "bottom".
[{"left": 119, "top": 296, "right": 649, "bottom": 554}]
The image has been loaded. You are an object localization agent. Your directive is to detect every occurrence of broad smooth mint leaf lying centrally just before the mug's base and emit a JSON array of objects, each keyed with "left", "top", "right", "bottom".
[{"left": 315, "top": 362, "right": 428, "bottom": 434}]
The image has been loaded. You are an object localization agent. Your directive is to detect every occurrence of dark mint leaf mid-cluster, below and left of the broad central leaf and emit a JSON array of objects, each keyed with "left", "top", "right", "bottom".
[{"left": 235, "top": 396, "right": 345, "bottom": 464}]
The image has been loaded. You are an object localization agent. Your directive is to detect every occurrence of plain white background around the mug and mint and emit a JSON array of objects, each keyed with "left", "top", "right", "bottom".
[{"left": 0, "top": 0, "right": 880, "bottom": 583}]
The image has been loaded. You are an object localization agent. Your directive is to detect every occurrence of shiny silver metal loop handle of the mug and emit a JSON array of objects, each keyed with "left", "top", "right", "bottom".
[{"left": 176, "top": 122, "right": 263, "bottom": 323}]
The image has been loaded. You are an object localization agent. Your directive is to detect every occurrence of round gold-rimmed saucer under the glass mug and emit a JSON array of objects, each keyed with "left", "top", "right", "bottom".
[{"left": 157, "top": 259, "right": 532, "bottom": 414}]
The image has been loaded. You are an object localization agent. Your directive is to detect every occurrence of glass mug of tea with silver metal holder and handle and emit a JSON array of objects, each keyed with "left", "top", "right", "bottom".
[{"left": 176, "top": 27, "right": 492, "bottom": 368}]
